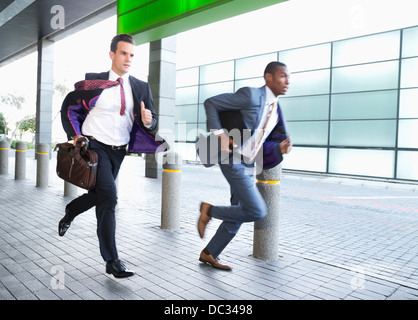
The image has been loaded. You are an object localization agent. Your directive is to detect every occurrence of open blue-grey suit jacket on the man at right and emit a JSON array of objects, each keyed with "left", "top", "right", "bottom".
[{"left": 205, "top": 86, "right": 288, "bottom": 169}]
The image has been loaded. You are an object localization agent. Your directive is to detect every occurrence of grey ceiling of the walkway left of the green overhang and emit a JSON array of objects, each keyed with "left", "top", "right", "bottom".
[{"left": 0, "top": 0, "right": 117, "bottom": 66}]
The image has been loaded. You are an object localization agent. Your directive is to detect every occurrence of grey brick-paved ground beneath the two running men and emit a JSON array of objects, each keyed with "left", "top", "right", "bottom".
[{"left": 0, "top": 151, "right": 418, "bottom": 301}]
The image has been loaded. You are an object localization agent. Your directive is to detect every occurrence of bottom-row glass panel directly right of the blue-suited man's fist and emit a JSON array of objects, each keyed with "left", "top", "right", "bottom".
[{"left": 282, "top": 147, "right": 327, "bottom": 172}]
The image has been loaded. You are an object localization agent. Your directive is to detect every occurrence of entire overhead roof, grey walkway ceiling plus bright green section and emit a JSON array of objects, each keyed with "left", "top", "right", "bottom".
[{"left": 0, "top": 0, "right": 287, "bottom": 67}]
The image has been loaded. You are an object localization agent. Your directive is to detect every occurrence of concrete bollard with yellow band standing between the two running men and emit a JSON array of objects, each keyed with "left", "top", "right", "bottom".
[{"left": 161, "top": 152, "right": 182, "bottom": 231}]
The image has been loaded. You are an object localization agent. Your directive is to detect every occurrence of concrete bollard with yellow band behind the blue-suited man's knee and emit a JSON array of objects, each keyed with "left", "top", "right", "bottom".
[{"left": 253, "top": 165, "right": 282, "bottom": 261}]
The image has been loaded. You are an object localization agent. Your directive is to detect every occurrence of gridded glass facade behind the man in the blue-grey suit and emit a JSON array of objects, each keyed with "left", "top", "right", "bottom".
[{"left": 175, "top": 27, "right": 418, "bottom": 181}]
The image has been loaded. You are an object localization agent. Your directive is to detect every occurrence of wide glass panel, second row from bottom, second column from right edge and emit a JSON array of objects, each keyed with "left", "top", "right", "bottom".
[{"left": 330, "top": 120, "right": 396, "bottom": 147}]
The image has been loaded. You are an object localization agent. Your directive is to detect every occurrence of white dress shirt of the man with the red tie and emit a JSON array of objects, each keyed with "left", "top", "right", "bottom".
[{"left": 82, "top": 70, "right": 134, "bottom": 146}]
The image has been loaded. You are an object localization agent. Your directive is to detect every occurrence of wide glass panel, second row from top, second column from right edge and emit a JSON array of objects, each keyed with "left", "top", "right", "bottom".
[{"left": 332, "top": 61, "right": 399, "bottom": 93}]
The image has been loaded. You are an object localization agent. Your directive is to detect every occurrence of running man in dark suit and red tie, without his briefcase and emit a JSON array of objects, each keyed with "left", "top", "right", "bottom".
[{"left": 58, "top": 34, "right": 162, "bottom": 278}]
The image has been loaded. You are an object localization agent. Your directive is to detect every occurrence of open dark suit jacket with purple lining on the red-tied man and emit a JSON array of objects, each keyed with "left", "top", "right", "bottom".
[{"left": 61, "top": 72, "right": 168, "bottom": 153}]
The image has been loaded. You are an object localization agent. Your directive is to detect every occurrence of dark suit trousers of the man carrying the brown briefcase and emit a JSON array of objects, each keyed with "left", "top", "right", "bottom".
[{"left": 67, "top": 139, "right": 126, "bottom": 261}]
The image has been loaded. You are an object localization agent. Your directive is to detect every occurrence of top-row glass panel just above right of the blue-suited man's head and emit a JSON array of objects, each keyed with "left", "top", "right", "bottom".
[{"left": 279, "top": 43, "right": 331, "bottom": 72}]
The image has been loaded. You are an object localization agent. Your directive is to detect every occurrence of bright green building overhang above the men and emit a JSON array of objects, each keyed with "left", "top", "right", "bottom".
[{"left": 118, "top": 0, "right": 287, "bottom": 44}]
